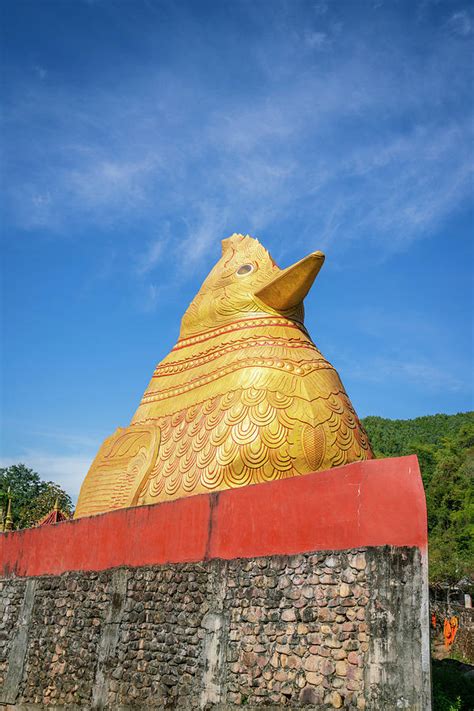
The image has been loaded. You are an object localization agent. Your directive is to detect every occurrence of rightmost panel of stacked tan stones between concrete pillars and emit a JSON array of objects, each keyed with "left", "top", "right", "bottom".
[{"left": 226, "top": 552, "right": 368, "bottom": 709}]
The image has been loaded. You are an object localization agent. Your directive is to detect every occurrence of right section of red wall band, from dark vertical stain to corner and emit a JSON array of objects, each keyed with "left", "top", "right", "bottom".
[{"left": 209, "top": 456, "right": 427, "bottom": 558}]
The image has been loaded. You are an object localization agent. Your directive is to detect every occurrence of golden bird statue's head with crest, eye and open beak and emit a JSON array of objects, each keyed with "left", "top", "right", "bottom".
[{"left": 180, "top": 234, "right": 324, "bottom": 338}]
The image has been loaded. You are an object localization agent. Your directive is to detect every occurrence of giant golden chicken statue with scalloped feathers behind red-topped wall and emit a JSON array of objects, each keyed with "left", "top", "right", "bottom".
[{"left": 75, "top": 234, "right": 373, "bottom": 517}]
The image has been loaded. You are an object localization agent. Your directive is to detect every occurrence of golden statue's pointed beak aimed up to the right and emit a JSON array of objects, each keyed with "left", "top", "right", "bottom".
[{"left": 255, "top": 252, "right": 324, "bottom": 311}]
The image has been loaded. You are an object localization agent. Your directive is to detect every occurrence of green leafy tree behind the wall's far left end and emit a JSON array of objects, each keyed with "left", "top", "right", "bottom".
[{"left": 0, "top": 464, "right": 73, "bottom": 528}]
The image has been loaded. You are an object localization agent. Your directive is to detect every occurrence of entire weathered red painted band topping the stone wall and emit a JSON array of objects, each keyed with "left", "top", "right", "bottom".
[{"left": 0, "top": 456, "right": 427, "bottom": 576}]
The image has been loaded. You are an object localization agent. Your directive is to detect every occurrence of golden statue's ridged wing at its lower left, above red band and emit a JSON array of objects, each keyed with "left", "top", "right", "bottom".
[{"left": 74, "top": 423, "right": 160, "bottom": 518}]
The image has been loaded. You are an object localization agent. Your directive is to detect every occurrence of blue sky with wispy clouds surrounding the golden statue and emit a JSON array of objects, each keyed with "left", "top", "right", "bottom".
[{"left": 1, "top": 0, "right": 474, "bottom": 495}]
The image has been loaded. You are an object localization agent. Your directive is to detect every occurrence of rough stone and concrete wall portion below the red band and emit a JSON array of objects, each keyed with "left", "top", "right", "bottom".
[{"left": 0, "top": 547, "right": 429, "bottom": 711}]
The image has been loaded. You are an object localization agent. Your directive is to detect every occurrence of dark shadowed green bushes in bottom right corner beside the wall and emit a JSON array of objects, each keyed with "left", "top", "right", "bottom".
[{"left": 432, "top": 659, "right": 474, "bottom": 711}]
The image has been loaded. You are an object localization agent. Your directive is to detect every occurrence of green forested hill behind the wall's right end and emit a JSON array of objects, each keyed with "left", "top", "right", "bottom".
[{"left": 363, "top": 412, "right": 474, "bottom": 583}]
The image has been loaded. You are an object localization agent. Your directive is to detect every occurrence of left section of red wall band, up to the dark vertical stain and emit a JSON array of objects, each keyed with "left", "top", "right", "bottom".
[{"left": 0, "top": 496, "right": 210, "bottom": 576}]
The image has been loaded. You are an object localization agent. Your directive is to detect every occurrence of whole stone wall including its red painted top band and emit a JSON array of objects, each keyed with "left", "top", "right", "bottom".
[{"left": 0, "top": 457, "right": 430, "bottom": 711}]
